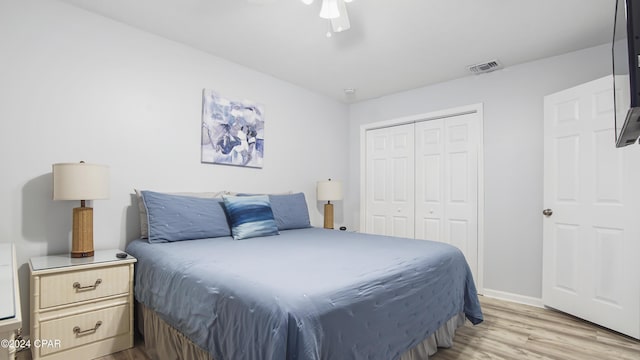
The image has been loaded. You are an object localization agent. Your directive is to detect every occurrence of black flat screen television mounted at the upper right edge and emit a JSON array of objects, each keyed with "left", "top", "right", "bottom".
[{"left": 612, "top": 0, "right": 640, "bottom": 147}]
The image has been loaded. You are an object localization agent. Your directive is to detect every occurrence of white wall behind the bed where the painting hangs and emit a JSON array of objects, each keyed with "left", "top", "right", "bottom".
[{"left": 0, "top": 0, "right": 348, "bottom": 331}]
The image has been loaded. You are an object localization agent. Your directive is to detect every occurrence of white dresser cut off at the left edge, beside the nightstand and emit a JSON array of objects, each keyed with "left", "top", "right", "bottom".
[{"left": 0, "top": 243, "right": 22, "bottom": 360}]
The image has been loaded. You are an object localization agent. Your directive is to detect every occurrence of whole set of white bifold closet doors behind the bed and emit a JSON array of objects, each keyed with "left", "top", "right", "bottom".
[{"left": 361, "top": 109, "right": 482, "bottom": 281}]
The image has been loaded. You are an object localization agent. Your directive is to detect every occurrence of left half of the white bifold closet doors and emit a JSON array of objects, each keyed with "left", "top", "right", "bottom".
[{"left": 365, "top": 124, "right": 415, "bottom": 238}]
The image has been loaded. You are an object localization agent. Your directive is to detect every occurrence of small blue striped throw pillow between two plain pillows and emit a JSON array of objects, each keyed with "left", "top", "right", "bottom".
[{"left": 222, "top": 195, "right": 279, "bottom": 240}]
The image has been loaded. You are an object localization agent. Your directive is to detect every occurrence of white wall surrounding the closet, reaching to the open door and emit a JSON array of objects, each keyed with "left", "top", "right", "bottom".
[{"left": 346, "top": 45, "right": 611, "bottom": 299}]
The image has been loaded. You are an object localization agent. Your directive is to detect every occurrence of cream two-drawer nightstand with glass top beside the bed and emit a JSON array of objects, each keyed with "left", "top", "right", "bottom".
[{"left": 29, "top": 250, "right": 136, "bottom": 360}]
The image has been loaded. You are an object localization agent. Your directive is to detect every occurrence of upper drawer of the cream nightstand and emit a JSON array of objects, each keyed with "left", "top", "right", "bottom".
[{"left": 40, "top": 265, "right": 129, "bottom": 309}]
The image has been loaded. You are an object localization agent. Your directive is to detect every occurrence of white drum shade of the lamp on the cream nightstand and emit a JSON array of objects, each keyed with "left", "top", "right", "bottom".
[{"left": 53, "top": 163, "right": 109, "bottom": 200}]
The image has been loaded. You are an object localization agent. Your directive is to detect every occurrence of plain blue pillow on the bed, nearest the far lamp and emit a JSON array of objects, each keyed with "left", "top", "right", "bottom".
[{"left": 269, "top": 193, "right": 311, "bottom": 230}]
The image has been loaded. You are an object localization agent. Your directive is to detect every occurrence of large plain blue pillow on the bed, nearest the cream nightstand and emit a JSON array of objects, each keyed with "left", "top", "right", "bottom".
[{"left": 142, "top": 191, "right": 231, "bottom": 243}]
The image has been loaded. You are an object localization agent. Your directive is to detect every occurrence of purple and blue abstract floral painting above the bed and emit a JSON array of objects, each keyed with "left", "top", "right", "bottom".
[{"left": 201, "top": 89, "right": 264, "bottom": 168}]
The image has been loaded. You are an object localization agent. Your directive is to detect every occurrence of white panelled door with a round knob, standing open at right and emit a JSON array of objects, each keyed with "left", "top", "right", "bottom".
[{"left": 541, "top": 77, "right": 640, "bottom": 338}]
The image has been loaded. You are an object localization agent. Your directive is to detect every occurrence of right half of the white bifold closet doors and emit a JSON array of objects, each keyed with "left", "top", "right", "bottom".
[{"left": 415, "top": 113, "right": 480, "bottom": 279}]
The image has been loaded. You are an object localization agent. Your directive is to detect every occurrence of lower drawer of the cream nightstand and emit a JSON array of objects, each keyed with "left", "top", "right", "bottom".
[{"left": 38, "top": 304, "right": 131, "bottom": 356}]
